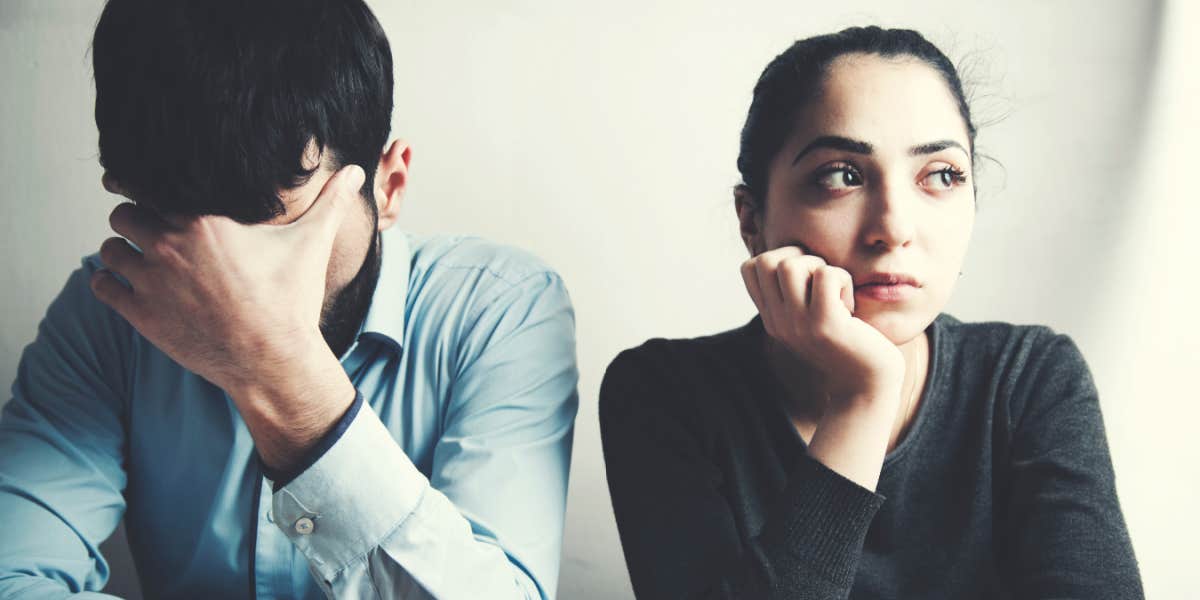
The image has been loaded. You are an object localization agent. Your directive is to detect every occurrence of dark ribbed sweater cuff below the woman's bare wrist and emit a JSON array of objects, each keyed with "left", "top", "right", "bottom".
[{"left": 761, "top": 454, "right": 886, "bottom": 586}]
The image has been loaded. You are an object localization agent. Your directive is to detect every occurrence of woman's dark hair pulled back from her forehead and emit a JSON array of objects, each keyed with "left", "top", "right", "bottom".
[{"left": 738, "top": 26, "right": 976, "bottom": 202}]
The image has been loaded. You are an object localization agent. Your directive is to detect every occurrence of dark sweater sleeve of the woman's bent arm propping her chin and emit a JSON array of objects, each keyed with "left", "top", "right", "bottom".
[{"left": 600, "top": 348, "right": 883, "bottom": 599}]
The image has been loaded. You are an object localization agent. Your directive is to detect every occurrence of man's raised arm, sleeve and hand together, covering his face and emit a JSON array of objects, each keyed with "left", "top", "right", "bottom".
[{"left": 91, "top": 166, "right": 577, "bottom": 598}]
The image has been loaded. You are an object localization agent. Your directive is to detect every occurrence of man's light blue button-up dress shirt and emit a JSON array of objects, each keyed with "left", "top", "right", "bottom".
[{"left": 0, "top": 232, "right": 578, "bottom": 600}]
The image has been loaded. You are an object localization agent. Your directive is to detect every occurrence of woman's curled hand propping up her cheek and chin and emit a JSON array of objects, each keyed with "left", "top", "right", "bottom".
[{"left": 742, "top": 246, "right": 905, "bottom": 408}]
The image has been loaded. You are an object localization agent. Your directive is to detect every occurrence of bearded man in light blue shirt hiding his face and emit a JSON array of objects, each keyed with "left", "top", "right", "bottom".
[{"left": 0, "top": 0, "right": 577, "bottom": 599}]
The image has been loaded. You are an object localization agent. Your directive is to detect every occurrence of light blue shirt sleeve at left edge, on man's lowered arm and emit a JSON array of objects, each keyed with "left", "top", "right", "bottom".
[{"left": 0, "top": 260, "right": 132, "bottom": 599}]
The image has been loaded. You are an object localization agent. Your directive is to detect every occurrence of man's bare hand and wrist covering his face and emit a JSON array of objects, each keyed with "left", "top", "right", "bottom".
[{"left": 91, "top": 166, "right": 365, "bottom": 469}]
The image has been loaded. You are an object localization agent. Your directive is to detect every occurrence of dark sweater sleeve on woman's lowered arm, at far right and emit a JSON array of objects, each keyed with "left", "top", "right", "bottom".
[{"left": 996, "top": 334, "right": 1145, "bottom": 599}]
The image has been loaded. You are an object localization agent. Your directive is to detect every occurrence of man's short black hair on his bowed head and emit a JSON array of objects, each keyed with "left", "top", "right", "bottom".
[{"left": 92, "top": 0, "right": 392, "bottom": 222}]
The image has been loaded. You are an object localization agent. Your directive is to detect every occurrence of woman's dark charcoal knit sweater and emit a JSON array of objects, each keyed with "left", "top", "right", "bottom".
[{"left": 600, "top": 314, "right": 1142, "bottom": 600}]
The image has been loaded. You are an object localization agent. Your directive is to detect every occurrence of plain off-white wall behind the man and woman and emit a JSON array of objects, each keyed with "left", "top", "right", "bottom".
[{"left": 0, "top": 0, "right": 1200, "bottom": 599}]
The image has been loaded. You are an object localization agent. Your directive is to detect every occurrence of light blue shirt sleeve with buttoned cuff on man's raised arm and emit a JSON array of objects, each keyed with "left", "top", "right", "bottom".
[{"left": 271, "top": 274, "right": 578, "bottom": 599}]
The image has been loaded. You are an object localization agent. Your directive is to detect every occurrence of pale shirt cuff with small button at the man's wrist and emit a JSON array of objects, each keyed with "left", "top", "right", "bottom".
[{"left": 271, "top": 404, "right": 430, "bottom": 581}]
